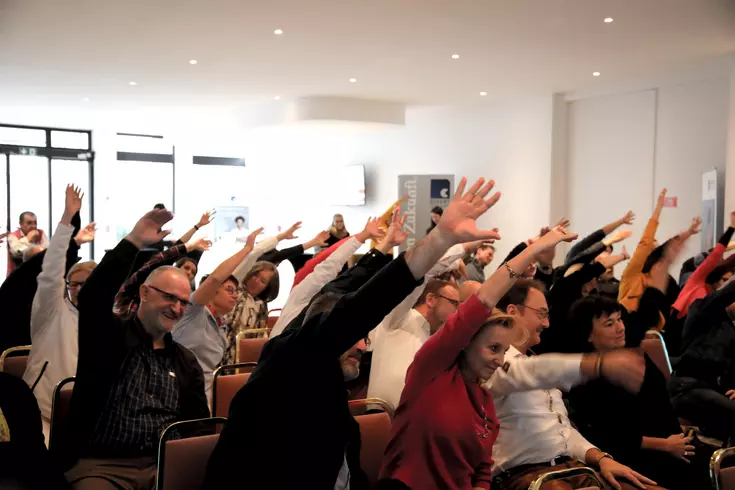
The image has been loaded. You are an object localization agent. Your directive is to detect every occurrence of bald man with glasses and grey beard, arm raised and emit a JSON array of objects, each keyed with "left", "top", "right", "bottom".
[{"left": 63, "top": 209, "right": 209, "bottom": 490}]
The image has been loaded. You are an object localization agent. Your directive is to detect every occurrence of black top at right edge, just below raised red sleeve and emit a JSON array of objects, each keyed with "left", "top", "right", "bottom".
[{"left": 676, "top": 281, "right": 735, "bottom": 392}]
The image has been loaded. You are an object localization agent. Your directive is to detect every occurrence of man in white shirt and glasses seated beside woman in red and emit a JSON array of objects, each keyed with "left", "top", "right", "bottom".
[{"left": 485, "top": 279, "right": 655, "bottom": 490}]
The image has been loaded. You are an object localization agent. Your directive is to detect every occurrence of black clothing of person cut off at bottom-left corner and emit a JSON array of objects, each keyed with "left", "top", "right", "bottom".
[{"left": 0, "top": 372, "right": 68, "bottom": 490}]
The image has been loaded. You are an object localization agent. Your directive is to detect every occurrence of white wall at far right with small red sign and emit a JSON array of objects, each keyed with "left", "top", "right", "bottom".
[{"left": 568, "top": 78, "right": 729, "bottom": 276}]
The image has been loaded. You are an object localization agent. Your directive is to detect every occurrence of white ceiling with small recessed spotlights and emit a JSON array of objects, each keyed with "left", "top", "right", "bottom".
[{"left": 0, "top": 0, "right": 735, "bottom": 107}]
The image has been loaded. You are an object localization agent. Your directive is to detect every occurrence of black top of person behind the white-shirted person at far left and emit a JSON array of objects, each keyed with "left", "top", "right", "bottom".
[{"left": 0, "top": 213, "right": 81, "bottom": 352}]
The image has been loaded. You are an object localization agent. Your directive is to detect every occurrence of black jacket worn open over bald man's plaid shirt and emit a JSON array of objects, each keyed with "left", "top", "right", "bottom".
[{"left": 63, "top": 240, "right": 209, "bottom": 463}]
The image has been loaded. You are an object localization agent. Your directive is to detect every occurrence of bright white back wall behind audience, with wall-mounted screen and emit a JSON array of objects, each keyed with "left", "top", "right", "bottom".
[{"left": 0, "top": 96, "right": 552, "bottom": 280}]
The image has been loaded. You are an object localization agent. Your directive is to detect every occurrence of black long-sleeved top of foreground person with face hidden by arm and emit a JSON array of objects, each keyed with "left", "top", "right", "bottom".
[{"left": 203, "top": 251, "right": 417, "bottom": 490}]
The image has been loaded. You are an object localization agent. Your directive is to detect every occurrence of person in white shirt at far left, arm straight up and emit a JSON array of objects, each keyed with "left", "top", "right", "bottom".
[{"left": 23, "top": 185, "right": 96, "bottom": 444}]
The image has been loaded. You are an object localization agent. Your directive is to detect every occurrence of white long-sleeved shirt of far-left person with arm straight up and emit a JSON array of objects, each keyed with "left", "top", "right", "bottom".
[{"left": 23, "top": 223, "right": 79, "bottom": 423}]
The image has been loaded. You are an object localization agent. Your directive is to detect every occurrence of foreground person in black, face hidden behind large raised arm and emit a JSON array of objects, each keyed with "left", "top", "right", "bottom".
[{"left": 204, "top": 179, "right": 506, "bottom": 490}]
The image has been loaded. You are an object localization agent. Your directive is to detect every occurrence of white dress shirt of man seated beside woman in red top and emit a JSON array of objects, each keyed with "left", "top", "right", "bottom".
[{"left": 484, "top": 347, "right": 595, "bottom": 475}]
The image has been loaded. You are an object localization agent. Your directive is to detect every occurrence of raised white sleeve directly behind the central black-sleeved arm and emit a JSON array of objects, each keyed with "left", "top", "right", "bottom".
[{"left": 270, "top": 236, "right": 362, "bottom": 338}]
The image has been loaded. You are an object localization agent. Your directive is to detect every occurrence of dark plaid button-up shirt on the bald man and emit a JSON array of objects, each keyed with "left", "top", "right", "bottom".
[{"left": 90, "top": 335, "right": 179, "bottom": 456}]
